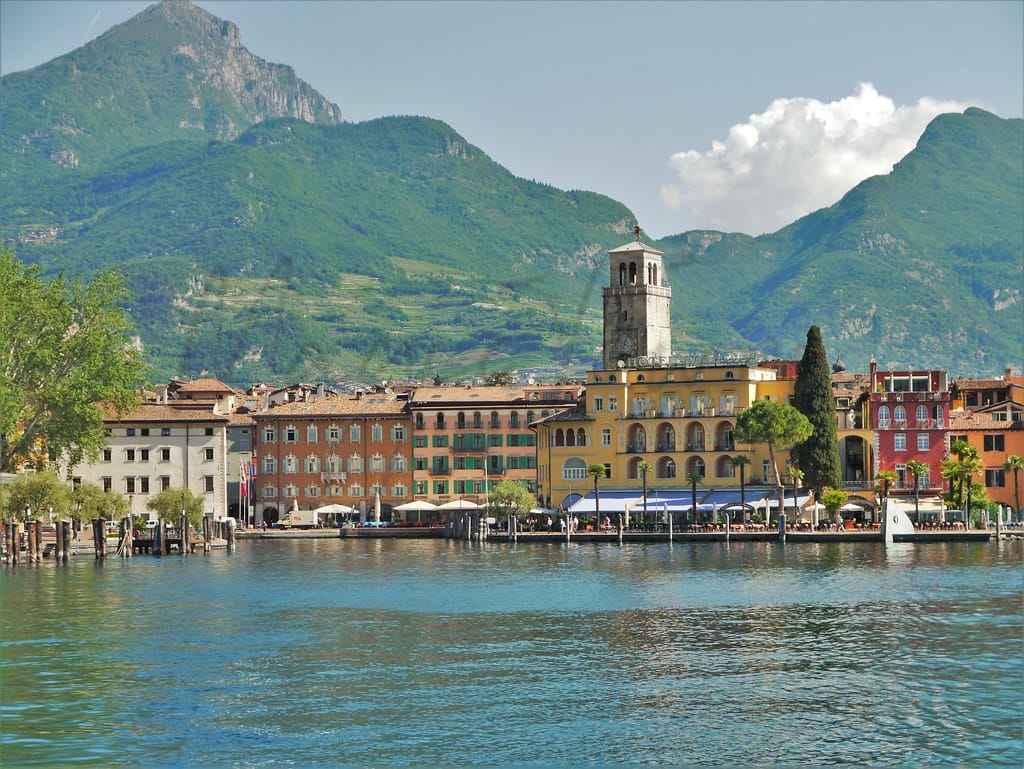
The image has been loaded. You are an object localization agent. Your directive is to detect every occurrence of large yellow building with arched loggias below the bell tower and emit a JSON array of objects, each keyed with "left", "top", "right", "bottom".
[{"left": 536, "top": 358, "right": 794, "bottom": 520}]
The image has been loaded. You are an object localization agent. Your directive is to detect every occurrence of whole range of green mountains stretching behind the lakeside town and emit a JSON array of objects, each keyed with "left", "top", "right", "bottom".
[{"left": 0, "top": 0, "right": 1024, "bottom": 383}]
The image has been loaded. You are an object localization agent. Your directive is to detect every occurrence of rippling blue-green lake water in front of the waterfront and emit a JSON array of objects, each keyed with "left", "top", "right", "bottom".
[{"left": 0, "top": 540, "right": 1024, "bottom": 768}]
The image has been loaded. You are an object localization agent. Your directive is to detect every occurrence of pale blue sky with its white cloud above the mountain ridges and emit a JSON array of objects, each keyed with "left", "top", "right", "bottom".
[{"left": 0, "top": 0, "right": 1024, "bottom": 238}]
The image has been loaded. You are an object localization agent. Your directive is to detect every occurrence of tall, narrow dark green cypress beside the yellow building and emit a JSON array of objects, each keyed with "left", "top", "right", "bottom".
[{"left": 793, "top": 326, "right": 841, "bottom": 499}]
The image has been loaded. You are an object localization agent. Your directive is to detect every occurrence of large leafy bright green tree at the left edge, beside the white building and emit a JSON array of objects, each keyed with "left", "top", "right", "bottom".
[{"left": 0, "top": 250, "right": 146, "bottom": 472}]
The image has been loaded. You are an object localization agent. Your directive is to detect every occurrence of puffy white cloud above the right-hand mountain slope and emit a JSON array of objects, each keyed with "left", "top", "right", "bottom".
[{"left": 662, "top": 83, "right": 968, "bottom": 234}]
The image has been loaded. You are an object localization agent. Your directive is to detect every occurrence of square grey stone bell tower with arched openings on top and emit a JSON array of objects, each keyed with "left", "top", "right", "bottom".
[{"left": 604, "top": 225, "right": 672, "bottom": 370}]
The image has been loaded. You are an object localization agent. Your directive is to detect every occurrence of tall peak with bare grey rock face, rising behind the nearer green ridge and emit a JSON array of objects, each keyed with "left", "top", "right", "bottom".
[{"left": 0, "top": 0, "right": 342, "bottom": 183}]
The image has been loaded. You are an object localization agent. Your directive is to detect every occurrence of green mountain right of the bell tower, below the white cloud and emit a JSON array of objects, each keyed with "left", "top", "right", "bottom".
[{"left": 662, "top": 109, "right": 1024, "bottom": 374}]
